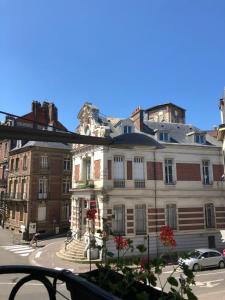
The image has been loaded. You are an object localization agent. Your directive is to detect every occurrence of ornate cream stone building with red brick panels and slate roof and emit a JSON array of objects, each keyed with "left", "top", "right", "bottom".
[{"left": 68, "top": 103, "right": 225, "bottom": 254}]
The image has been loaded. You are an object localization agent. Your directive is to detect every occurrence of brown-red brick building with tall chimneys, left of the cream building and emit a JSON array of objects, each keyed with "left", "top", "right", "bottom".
[{"left": 1, "top": 101, "right": 71, "bottom": 233}]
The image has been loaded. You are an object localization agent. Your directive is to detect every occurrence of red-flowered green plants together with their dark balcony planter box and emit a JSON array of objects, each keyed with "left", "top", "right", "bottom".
[{"left": 80, "top": 221, "right": 197, "bottom": 300}]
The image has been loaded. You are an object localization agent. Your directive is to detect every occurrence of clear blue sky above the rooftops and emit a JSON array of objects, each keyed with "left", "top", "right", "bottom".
[{"left": 0, "top": 0, "right": 225, "bottom": 130}]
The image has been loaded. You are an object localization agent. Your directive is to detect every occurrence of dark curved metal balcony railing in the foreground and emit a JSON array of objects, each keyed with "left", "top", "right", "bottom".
[{"left": 0, "top": 265, "right": 118, "bottom": 300}]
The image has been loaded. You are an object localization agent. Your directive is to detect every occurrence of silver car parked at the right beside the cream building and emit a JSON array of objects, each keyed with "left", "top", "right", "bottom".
[{"left": 178, "top": 248, "right": 225, "bottom": 271}]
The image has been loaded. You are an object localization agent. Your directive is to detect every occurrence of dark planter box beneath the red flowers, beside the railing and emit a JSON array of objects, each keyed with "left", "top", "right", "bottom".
[{"left": 79, "top": 268, "right": 171, "bottom": 300}]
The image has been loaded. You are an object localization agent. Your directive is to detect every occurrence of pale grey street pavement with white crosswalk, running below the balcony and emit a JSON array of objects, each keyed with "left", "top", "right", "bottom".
[{"left": 0, "top": 227, "right": 225, "bottom": 300}]
